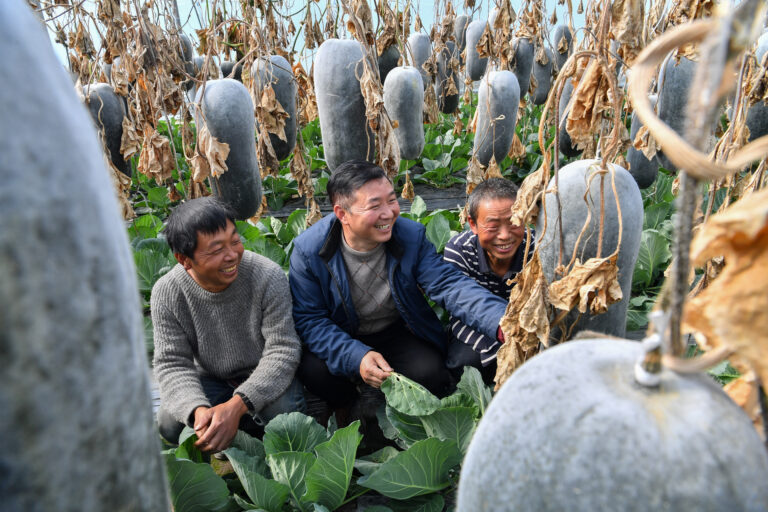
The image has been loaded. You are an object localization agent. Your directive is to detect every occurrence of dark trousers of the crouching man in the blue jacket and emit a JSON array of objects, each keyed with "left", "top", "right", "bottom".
[{"left": 297, "top": 321, "right": 451, "bottom": 408}]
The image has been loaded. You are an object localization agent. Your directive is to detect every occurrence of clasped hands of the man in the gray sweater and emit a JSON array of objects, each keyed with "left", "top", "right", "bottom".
[{"left": 194, "top": 395, "right": 248, "bottom": 452}]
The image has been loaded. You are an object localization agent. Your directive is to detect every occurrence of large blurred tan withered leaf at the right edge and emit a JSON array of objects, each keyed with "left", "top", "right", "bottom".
[{"left": 683, "top": 189, "right": 768, "bottom": 388}]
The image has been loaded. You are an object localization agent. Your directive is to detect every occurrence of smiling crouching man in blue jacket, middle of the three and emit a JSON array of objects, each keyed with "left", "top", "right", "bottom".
[{"left": 289, "top": 160, "right": 506, "bottom": 409}]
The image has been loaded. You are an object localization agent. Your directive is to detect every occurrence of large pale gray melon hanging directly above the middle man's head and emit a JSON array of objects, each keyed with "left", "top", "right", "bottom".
[{"left": 314, "top": 39, "right": 374, "bottom": 172}]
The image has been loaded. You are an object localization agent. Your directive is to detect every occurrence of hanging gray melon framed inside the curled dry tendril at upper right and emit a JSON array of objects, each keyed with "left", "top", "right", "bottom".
[{"left": 657, "top": 57, "right": 696, "bottom": 170}]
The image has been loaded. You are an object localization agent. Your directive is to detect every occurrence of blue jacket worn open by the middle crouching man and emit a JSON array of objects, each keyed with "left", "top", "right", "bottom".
[{"left": 288, "top": 213, "right": 506, "bottom": 377}]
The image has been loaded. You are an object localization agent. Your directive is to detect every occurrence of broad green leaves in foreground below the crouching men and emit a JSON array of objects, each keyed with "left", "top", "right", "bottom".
[{"left": 164, "top": 368, "right": 491, "bottom": 512}]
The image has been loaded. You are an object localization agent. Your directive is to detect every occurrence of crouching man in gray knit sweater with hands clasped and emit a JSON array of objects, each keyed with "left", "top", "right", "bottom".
[{"left": 151, "top": 197, "right": 304, "bottom": 452}]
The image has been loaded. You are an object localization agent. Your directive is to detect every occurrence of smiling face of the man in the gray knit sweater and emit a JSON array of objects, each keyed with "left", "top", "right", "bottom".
[{"left": 176, "top": 220, "right": 244, "bottom": 292}]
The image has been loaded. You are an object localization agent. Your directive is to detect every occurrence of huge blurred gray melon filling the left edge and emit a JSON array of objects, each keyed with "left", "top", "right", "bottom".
[{"left": 0, "top": 0, "right": 170, "bottom": 512}]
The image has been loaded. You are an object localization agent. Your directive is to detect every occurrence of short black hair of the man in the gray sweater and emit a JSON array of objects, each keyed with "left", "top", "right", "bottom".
[{"left": 163, "top": 196, "right": 236, "bottom": 258}]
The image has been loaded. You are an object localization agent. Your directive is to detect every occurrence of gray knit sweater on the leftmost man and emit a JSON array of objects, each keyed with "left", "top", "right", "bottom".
[{"left": 151, "top": 251, "right": 301, "bottom": 424}]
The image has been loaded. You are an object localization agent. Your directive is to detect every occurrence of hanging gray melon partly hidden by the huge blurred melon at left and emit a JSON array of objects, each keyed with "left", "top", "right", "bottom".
[{"left": 83, "top": 83, "right": 131, "bottom": 176}]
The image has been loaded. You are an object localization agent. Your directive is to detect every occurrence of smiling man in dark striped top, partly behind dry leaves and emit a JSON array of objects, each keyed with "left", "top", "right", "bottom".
[{"left": 443, "top": 178, "right": 533, "bottom": 383}]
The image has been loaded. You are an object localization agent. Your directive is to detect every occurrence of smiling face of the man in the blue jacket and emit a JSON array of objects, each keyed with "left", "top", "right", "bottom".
[{"left": 333, "top": 178, "right": 400, "bottom": 252}]
